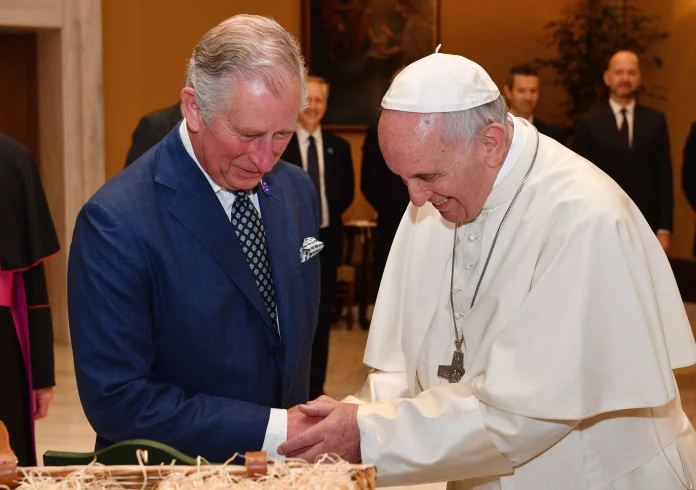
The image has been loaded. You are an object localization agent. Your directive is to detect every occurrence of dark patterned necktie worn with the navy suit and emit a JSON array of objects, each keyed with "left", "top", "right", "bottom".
[{"left": 231, "top": 191, "right": 278, "bottom": 332}]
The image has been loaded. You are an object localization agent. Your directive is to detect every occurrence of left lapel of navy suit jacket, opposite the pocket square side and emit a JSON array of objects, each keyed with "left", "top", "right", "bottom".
[{"left": 155, "top": 133, "right": 275, "bottom": 333}]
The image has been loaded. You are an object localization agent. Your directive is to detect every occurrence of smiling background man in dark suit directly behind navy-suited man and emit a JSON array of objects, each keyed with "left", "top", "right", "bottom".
[{"left": 282, "top": 76, "right": 355, "bottom": 399}]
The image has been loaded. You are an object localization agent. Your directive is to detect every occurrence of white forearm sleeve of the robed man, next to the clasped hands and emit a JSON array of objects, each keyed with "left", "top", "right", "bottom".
[{"left": 358, "top": 384, "right": 512, "bottom": 486}]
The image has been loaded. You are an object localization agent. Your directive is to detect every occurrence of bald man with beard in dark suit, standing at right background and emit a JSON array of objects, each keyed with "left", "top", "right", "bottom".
[{"left": 574, "top": 51, "right": 674, "bottom": 252}]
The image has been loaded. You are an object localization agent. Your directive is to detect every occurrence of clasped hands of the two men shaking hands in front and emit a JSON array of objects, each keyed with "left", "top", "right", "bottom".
[{"left": 278, "top": 396, "right": 361, "bottom": 463}]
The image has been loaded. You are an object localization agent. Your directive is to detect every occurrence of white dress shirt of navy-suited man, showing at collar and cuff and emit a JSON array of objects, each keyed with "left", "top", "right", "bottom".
[{"left": 179, "top": 118, "right": 288, "bottom": 459}]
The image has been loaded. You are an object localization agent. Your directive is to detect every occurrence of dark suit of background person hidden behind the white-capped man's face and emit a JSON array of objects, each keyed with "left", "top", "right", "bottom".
[{"left": 360, "top": 124, "right": 410, "bottom": 287}]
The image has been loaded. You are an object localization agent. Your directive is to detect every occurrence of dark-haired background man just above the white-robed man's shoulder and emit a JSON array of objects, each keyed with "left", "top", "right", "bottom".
[{"left": 503, "top": 65, "right": 563, "bottom": 143}]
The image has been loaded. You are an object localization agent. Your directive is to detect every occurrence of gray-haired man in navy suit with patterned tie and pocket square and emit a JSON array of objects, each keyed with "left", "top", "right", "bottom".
[{"left": 68, "top": 15, "right": 321, "bottom": 462}]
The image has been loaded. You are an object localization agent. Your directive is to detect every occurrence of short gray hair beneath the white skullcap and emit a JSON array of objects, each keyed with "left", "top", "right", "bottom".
[{"left": 441, "top": 95, "right": 508, "bottom": 147}]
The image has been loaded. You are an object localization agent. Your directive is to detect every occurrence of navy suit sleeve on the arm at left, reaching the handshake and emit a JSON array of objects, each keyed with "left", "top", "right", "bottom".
[{"left": 68, "top": 201, "right": 270, "bottom": 462}]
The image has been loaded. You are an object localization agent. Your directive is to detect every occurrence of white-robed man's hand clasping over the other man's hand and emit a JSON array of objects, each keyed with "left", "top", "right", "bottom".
[{"left": 278, "top": 399, "right": 362, "bottom": 463}]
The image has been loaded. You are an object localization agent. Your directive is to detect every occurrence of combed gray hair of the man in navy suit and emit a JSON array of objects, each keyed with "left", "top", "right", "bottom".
[{"left": 186, "top": 15, "right": 307, "bottom": 126}]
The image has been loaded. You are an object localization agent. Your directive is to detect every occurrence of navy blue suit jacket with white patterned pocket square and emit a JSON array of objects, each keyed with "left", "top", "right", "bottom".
[{"left": 68, "top": 128, "right": 320, "bottom": 462}]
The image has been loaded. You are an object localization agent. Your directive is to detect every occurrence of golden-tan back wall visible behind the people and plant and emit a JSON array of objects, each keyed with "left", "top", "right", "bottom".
[{"left": 102, "top": 0, "right": 696, "bottom": 258}]
